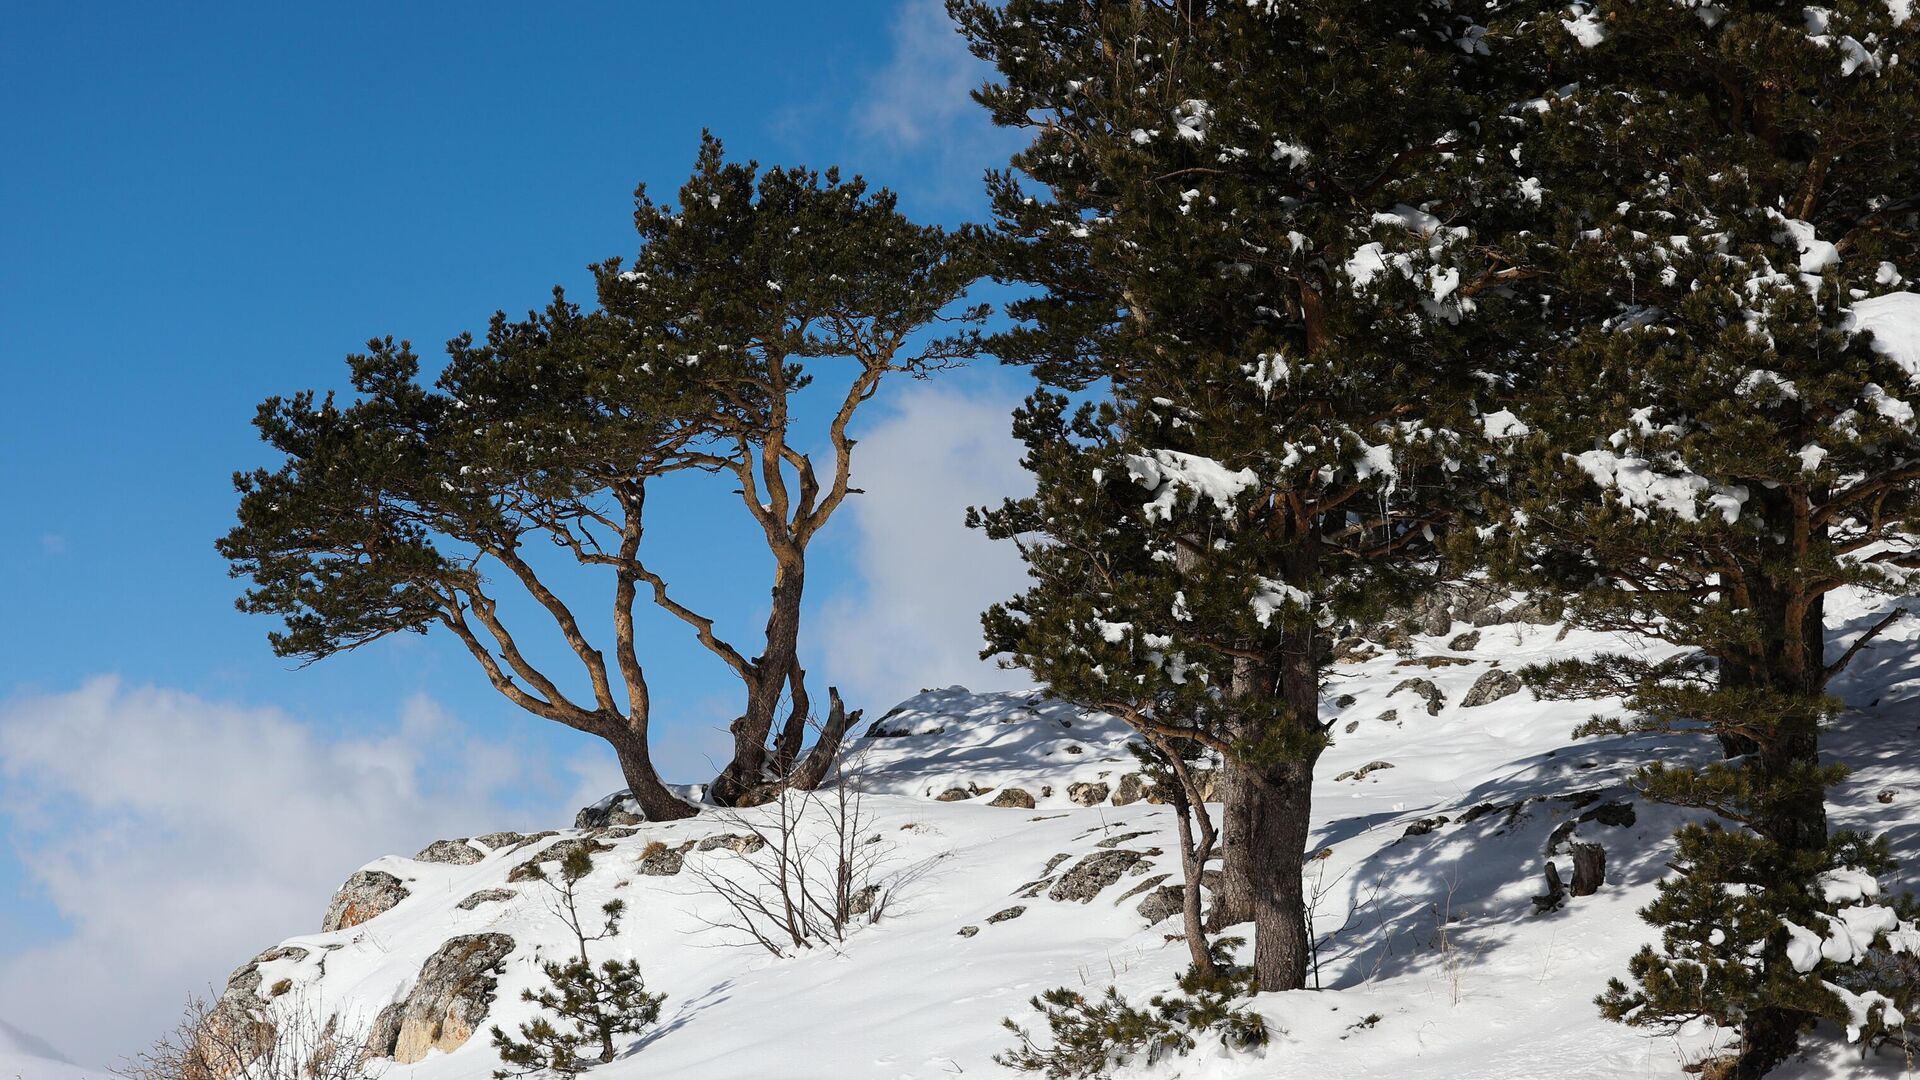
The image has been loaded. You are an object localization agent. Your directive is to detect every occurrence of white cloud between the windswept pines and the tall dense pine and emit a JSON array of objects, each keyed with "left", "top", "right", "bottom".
[{"left": 810, "top": 384, "right": 1033, "bottom": 715}]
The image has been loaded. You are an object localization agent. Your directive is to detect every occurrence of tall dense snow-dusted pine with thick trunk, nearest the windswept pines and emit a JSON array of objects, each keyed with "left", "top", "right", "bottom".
[{"left": 967, "top": 0, "right": 1519, "bottom": 990}]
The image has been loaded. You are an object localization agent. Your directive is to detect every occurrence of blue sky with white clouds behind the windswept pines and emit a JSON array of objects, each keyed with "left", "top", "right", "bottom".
[{"left": 0, "top": 0, "right": 1023, "bottom": 1061}]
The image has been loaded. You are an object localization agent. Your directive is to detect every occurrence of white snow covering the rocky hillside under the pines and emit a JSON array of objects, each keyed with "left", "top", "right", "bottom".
[{"left": 157, "top": 598, "right": 1920, "bottom": 1080}]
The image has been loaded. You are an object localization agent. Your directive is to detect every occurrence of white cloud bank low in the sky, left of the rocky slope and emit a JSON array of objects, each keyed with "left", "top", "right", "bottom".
[{"left": 0, "top": 678, "right": 579, "bottom": 1065}]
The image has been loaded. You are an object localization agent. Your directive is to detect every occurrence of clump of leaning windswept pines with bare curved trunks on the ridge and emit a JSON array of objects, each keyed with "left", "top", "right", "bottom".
[{"left": 219, "top": 138, "right": 983, "bottom": 821}]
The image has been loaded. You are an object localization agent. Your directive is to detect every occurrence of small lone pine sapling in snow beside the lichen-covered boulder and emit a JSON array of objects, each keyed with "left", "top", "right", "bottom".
[{"left": 493, "top": 847, "right": 666, "bottom": 1080}]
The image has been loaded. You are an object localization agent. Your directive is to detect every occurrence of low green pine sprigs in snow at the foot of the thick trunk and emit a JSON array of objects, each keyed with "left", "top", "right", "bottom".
[{"left": 993, "top": 938, "right": 1269, "bottom": 1080}]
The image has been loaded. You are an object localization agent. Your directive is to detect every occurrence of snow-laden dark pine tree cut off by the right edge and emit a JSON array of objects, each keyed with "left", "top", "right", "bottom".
[{"left": 1482, "top": 0, "right": 1920, "bottom": 1076}]
